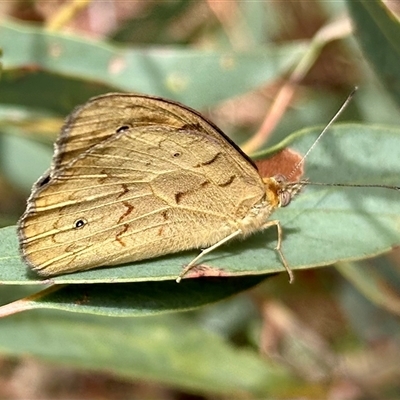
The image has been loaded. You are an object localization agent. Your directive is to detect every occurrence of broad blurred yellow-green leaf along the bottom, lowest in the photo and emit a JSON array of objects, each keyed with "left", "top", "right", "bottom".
[{"left": 0, "top": 310, "right": 294, "bottom": 397}]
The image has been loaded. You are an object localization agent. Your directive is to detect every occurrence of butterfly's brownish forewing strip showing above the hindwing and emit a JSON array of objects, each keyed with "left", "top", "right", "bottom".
[{"left": 52, "top": 93, "right": 260, "bottom": 170}]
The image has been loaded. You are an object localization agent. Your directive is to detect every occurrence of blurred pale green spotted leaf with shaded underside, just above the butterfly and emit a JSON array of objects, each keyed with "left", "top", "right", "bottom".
[{"left": 0, "top": 21, "right": 305, "bottom": 113}]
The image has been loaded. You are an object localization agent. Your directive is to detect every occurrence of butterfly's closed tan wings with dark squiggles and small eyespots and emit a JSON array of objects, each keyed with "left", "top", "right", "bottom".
[{"left": 19, "top": 95, "right": 265, "bottom": 276}]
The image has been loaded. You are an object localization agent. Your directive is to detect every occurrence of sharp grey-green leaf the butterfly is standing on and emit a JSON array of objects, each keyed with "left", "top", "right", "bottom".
[{"left": 0, "top": 124, "right": 400, "bottom": 284}]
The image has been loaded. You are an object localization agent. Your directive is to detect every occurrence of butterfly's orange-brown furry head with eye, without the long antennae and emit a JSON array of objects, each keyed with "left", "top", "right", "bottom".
[{"left": 263, "top": 175, "right": 306, "bottom": 207}]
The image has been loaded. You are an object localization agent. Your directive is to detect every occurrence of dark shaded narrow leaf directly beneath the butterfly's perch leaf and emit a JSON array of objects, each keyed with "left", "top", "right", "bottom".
[{"left": 0, "top": 275, "right": 265, "bottom": 317}]
